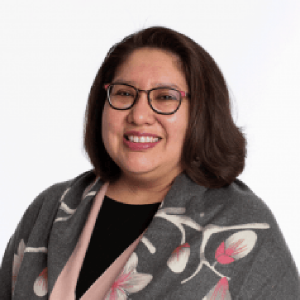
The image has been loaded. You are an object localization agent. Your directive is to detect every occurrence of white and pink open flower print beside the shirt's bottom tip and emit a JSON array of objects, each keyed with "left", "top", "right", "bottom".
[{"left": 105, "top": 252, "right": 152, "bottom": 300}]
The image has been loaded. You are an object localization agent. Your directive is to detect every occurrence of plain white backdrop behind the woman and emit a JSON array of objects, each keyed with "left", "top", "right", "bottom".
[{"left": 0, "top": 0, "right": 300, "bottom": 268}]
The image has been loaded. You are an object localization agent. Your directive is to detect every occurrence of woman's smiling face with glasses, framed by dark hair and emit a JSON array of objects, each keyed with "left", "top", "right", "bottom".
[{"left": 102, "top": 48, "right": 189, "bottom": 185}]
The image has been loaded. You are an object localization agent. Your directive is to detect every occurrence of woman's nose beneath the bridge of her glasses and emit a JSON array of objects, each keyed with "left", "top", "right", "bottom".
[{"left": 128, "top": 91, "right": 155, "bottom": 125}]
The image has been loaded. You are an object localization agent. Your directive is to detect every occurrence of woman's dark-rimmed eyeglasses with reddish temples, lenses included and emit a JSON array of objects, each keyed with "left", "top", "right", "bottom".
[{"left": 104, "top": 83, "right": 189, "bottom": 115}]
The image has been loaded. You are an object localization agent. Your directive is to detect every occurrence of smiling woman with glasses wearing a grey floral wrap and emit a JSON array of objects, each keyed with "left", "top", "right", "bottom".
[{"left": 0, "top": 27, "right": 300, "bottom": 300}]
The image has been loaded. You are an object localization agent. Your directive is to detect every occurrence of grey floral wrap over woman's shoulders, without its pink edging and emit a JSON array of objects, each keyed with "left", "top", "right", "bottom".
[{"left": 0, "top": 171, "right": 300, "bottom": 300}]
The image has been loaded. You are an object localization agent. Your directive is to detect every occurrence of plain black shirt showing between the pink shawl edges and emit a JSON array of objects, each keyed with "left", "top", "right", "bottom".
[{"left": 76, "top": 196, "right": 160, "bottom": 299}]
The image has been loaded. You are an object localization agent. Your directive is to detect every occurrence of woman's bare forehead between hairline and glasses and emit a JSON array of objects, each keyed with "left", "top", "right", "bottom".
[{"left": 114, "top": 48, "right": 187, "bottom": 89}]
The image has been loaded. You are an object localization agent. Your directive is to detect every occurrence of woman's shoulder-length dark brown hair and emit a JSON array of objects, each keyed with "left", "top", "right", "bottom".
[{"left": 84, "top": 27, "right": 246, "bottom": 188}]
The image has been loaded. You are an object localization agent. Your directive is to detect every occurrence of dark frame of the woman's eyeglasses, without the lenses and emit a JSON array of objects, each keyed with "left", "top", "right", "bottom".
[{"left": 104, "top": 82, "right": 190, "bottom": 115}]
